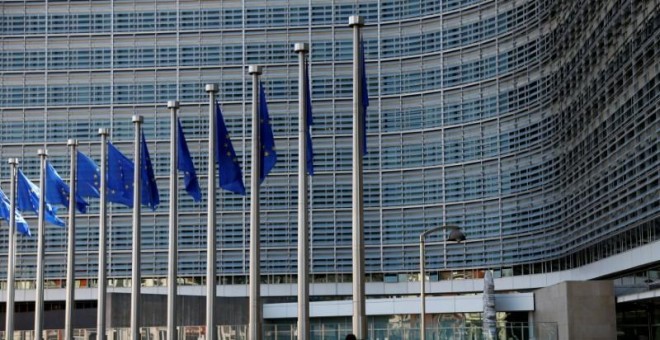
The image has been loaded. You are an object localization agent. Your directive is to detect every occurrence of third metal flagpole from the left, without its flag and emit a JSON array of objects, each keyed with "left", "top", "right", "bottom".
[{"left": 64, "top": 139, "right": 78, "bottom": 340}]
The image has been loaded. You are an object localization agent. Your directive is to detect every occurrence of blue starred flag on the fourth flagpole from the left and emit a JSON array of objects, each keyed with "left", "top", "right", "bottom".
[{"left": 107, "top": 142, "right": 135, "bottom": 208}]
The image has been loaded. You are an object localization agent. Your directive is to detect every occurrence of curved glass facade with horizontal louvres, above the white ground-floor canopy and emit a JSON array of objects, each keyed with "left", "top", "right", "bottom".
[{"left": 0, "top": 0, "right": 660, "bottom": 283}]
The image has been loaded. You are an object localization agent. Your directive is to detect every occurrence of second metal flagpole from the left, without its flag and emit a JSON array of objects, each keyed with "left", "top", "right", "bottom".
[{"left": 34, "top": 149, "right": 48, "bottom": 340}]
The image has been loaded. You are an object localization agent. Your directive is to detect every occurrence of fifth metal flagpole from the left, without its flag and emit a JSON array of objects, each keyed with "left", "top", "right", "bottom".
[{"left": 131, "top": 115, "right": 143, "bottom": 340}]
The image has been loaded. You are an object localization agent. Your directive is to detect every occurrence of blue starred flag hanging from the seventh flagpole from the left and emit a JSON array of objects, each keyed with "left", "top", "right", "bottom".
[{"left": 215, "top": 102, "right": 245, "bottom": 195}]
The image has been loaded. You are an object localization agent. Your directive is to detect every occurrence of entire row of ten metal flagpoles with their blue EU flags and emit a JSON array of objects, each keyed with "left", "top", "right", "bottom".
[{"left": 0, "top": 16, "right": 369, "bottom": 340}]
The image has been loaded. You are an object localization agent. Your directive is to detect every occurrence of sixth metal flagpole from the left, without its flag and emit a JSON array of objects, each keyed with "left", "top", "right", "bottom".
[{"left": 167, "top": 100, "right": 179, "bottom": 340}]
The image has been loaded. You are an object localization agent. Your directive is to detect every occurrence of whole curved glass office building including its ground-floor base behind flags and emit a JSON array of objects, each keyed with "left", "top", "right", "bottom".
[{"left": 0, "top": 0, "right": 660, "bottom": 339}]
